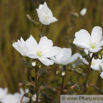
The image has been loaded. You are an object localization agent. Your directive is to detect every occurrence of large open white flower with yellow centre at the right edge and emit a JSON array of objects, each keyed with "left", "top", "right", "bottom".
[{"left": 73, "top": 26, "right": 103, "bottom": 53}]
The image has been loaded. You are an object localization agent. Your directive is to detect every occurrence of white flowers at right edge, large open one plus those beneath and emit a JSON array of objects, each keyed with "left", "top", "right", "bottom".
[{"left": 73, "top": 26, "right": 103, "bottom": 78}]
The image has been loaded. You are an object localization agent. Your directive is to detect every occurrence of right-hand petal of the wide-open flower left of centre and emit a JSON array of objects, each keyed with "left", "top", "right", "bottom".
[{"left": 43, "top": 47, "right": 60, "bottom": 57}]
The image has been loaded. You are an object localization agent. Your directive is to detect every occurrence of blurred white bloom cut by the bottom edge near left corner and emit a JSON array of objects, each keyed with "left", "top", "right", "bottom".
[{"left": 2, "top": 94, "right": 20, "bottom": 103}]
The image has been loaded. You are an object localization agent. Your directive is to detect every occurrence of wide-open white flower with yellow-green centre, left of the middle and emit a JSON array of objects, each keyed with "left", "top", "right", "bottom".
[{"left": 26, "top": 36, "right": 59, "bottom": 66}]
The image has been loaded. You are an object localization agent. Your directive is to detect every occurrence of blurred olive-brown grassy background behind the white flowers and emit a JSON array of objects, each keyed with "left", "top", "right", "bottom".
[{"left": 0, "top": 0, "right": 103, "bottom": 94}]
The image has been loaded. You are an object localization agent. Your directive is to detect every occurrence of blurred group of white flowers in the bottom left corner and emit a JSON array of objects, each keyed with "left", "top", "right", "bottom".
[{"left": 0, "top": 88, "right": 36, "bottom": 103}]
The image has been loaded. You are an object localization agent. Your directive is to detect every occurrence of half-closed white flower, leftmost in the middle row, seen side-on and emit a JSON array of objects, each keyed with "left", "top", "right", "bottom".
[{"left": 12, "top": 36, "right": 36, "bottom": 56}]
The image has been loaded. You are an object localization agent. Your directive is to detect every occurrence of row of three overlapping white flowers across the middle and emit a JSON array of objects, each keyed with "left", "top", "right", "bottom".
[{"left": 13, "top": 35, "right": 78, "bottom": 66}]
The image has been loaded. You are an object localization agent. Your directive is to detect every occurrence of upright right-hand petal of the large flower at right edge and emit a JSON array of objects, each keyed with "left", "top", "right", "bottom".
[{"left": 91, "top": 26, "right": 102, "bottom": 44}]
